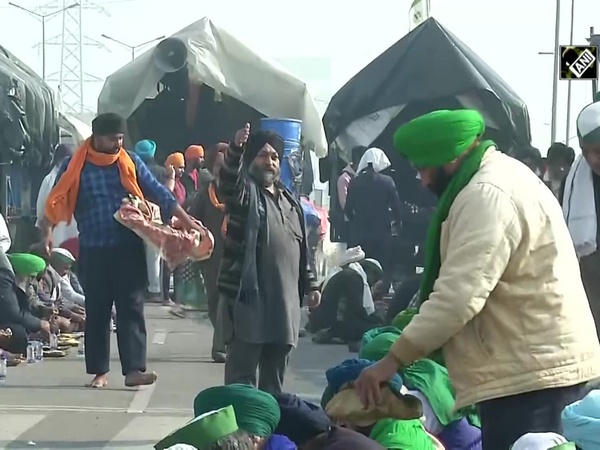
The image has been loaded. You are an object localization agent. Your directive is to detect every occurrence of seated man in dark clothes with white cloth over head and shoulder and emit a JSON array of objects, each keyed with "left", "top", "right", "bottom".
[{"left": 308, "top": 247, "right": 384, "bottom": 350}]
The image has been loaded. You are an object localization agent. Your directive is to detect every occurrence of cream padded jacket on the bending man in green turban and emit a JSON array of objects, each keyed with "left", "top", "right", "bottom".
[{"left": 392, "top": 149, "right": 600, "bottom": 408}]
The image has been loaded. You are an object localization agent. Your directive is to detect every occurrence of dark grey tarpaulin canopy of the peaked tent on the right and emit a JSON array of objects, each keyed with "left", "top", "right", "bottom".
[{"left": 323, "top": 18, "right": 531, "bottom": 165}]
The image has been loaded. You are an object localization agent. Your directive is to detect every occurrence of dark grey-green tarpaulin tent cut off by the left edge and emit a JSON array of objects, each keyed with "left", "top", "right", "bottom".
[{"left": 0, "top": 46, "right": 59, "bottom": 167}]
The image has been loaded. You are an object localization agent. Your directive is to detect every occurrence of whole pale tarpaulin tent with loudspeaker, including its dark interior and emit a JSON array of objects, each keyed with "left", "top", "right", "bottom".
[{"left": 98, "top": 17, "right": 327, "bottom": 157}]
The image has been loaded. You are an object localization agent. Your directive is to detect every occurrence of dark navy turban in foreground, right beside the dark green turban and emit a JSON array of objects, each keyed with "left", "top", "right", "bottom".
[{"left": 275, "top": 393, "right": 333, "bottom": 446}]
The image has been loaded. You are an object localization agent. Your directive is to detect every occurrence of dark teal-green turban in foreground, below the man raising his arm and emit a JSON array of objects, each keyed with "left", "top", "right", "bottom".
[{"left": 194, "top": 384, "right": 281, "bottom": 437}]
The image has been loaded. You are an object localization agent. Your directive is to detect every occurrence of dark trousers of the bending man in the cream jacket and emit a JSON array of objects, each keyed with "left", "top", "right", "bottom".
[{"left": 479, "top": 383, "right": 585, "bottom": 450}]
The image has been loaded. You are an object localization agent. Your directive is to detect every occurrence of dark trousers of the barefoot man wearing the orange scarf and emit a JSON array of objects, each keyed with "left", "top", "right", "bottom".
[{"left": 79, "top": 240, "right": 148, "bottom": 375}]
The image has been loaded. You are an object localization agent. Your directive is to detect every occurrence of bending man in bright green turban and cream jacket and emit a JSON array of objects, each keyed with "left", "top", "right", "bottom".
[{"left": 356, "top": 110, "right": 600, "bottom": 450}]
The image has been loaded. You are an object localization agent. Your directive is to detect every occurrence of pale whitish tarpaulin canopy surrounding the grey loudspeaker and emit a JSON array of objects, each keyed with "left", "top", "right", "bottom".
[{"left": 98, "top": 17, "right": 327, "bottom": 157}]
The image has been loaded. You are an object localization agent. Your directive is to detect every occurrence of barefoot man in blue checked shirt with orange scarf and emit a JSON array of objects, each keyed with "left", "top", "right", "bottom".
[{"left": 44, "top": 113, "right": 204, "bottom": 388}]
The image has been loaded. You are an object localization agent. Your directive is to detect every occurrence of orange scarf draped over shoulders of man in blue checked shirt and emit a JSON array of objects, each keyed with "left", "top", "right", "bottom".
[{"left": 45, "top": 138, "right": 144, "bottom": 225}]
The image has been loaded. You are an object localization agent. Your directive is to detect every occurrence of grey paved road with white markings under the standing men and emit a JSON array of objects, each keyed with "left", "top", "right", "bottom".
[{"left": 0, "top": 306, "right": 349, "bottom": 450}]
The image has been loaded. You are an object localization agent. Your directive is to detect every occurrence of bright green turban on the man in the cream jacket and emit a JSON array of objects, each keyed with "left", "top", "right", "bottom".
[{"left": 394, "top": 109, "right": 485, "bottom": 168}]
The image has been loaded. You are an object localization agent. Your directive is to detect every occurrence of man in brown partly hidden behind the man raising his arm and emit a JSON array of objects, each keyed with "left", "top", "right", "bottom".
[{"left": 189, "top": 142, "right": 229, "bottom": 363}]
